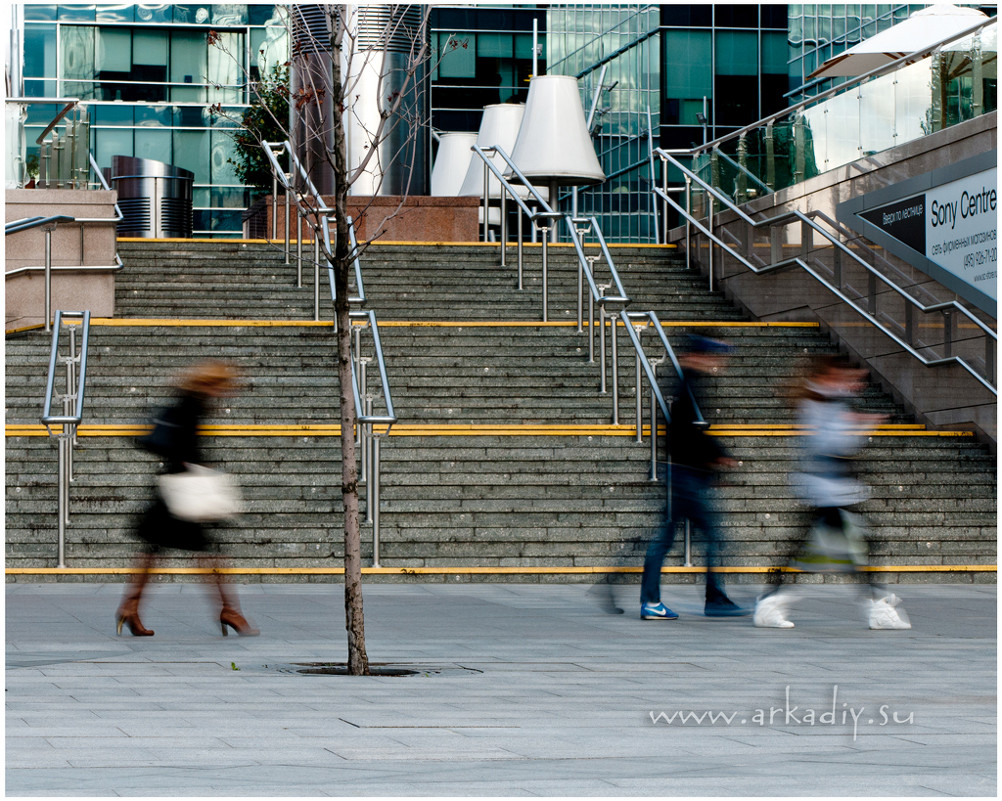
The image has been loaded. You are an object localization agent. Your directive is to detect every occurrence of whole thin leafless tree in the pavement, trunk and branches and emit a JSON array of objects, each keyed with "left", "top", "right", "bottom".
[{"left": 209, "top": 4, "right": 442, "bottom": 675}]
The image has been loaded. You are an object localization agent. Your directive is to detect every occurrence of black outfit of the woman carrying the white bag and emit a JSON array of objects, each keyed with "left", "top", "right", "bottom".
[{"left": 136, "top": 394, "right": 212, "bottom": 552}]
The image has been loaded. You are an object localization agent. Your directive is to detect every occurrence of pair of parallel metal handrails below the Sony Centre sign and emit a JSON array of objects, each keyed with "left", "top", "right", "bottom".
[{"left": 654, "top": 150, "right": 998, "bottom": 396}]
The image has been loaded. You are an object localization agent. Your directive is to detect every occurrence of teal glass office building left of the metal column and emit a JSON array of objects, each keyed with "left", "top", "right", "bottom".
[{"left": 22, "top": 3, "right": 288, "bottom": 237}]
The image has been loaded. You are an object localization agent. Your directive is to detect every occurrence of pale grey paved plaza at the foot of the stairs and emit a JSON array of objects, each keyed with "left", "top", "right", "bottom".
[{"left": 6, "top": 583, "right": 997, "bottom": 797}]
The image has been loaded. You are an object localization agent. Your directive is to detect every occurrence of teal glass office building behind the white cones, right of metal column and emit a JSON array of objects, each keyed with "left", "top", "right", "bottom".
[{"left": 431, "top": 3, "right": 790, "bottom": 242}]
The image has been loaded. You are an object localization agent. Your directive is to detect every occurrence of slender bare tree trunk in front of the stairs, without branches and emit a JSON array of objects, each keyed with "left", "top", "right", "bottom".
[{"left": 331, "top": 14, "right": 369, "bottom": 676}]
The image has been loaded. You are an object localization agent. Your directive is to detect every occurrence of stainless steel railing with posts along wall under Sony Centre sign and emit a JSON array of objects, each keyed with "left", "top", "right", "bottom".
[{"left": 654, "top": 150, "right": 998, "bottom": 396}]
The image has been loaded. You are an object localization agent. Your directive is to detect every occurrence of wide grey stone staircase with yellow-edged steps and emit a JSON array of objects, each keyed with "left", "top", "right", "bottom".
[{"left": 6, "top": 242, "right": 996, "bottom": 580}]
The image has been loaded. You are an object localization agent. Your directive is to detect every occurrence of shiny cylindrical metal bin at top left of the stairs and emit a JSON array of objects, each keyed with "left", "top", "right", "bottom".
[{"left": 110, "top": 155, "right": 194, "bottom": 239}]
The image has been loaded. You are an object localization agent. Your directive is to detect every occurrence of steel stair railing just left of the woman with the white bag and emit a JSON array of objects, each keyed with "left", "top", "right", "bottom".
[{"left": 41, "top": 311, "right": 90, "bottom": 567}]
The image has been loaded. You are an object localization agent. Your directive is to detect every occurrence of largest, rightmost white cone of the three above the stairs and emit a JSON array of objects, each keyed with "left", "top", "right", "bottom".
[{"left": 511, "top": 75, "right": 605, "bottom": 187}]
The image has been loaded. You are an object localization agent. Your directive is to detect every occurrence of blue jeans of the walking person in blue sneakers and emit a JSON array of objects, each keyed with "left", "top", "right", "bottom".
[{"left": 640, "top": 464, "right": 724, "bottom": 604}]
